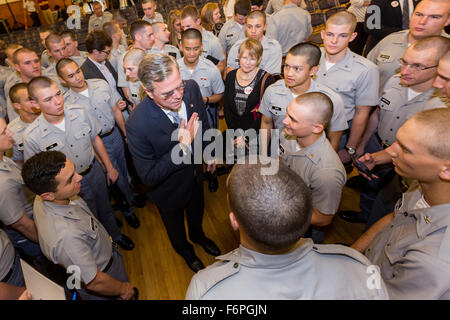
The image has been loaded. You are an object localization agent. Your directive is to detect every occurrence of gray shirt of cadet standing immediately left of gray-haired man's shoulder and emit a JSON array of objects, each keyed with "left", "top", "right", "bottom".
[{"left": 64, "top": 79, "right": 122, "bottom": 134}]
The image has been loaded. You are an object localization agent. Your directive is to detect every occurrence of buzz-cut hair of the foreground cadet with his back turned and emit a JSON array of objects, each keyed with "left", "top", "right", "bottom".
[{"left": 227, "top": 161, "right": 312, "bottom": 251}]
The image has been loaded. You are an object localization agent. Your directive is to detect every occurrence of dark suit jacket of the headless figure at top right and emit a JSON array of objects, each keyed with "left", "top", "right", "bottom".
[{"left": 364, "top": 0, "right": 420, "bottom": 56}]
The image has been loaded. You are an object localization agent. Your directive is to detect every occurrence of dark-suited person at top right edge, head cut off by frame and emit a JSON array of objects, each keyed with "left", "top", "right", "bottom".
[{"left": 363, "top": 0, "right": 420, "bottom": 57}]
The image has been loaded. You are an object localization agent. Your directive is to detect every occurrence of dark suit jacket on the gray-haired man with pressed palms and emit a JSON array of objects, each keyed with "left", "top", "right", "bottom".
[{"left": 126, "top": 80, "right": 208, "bottom": 210}]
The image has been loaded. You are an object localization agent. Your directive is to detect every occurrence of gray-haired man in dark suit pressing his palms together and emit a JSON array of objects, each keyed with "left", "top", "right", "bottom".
[{"left": 126, "top": 53, "right": 220, "bottom": 272}]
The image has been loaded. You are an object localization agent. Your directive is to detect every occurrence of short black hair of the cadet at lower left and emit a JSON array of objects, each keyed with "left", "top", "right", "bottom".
[{"left": 22, "top": 151, "right": 66, "bottom": 195}]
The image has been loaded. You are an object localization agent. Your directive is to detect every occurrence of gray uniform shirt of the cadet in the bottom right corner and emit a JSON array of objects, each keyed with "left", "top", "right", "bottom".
[{"left": 365, "top": 189, "right": 450, "bottom": 300}]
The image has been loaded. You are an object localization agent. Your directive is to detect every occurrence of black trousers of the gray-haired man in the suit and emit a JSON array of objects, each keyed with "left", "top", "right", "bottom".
[{"left": 158, "top": 179, "right": 205, "bottom": 257}]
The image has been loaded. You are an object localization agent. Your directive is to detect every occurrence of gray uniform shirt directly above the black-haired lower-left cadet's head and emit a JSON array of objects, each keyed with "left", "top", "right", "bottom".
[{"left": 24, "top": 104, "right": 102, "bottom": 173}]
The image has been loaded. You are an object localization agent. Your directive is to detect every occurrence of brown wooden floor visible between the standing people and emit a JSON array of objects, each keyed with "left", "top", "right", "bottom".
[{"left": 117, "top": 165, "right": 364, "bottom": 300}]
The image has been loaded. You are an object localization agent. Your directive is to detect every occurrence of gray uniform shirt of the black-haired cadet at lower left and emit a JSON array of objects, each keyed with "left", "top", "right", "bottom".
[{"left": 34, "top": 196, "right": 112, "bottom": 284}]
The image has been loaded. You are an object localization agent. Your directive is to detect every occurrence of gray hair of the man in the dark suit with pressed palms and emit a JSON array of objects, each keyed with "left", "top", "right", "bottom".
[{"left": 138, "top": 53, "right": 178, "bottom": 91}]
